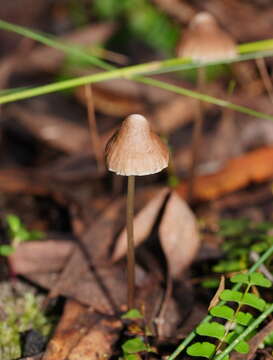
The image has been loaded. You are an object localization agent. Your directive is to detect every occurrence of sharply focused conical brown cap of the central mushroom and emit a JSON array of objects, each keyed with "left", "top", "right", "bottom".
[{"left": 105, "top": 114, "right": 169, "bottom": 176}]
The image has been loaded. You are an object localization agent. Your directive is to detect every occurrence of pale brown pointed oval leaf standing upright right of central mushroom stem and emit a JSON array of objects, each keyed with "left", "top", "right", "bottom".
[{"left": 159, "top": 191, "right": 200, "bottom": 277}]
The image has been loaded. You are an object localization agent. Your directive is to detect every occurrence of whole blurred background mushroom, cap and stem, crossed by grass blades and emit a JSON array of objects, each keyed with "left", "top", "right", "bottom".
[{"left": 177, "top": 12, "right": 237, "bottom": 201}]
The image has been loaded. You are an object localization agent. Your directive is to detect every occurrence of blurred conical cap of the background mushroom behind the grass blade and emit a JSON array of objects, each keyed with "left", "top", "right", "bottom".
[{"left": 177, "top": 12, "right": 237, "bottom": 62}]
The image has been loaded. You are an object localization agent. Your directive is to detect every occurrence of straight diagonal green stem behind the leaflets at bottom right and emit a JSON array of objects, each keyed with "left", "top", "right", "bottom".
[{"left": 168, "top": 245, "right": 273, "bottom": 360}]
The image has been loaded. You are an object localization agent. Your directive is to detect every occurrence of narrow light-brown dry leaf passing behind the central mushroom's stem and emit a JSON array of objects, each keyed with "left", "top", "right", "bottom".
[{"left": 112, "top": 188, "right": 168, "bottom": 261}]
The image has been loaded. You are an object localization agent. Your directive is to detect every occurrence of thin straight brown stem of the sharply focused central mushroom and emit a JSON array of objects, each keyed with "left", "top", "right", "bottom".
[{"left": 127, "top": 175, "right": 135, "bottom": 310}]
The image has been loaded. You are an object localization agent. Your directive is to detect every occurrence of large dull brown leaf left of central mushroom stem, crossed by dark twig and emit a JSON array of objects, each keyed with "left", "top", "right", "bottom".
[{"left": 27, "top": 188, "right": 168, "bottom": 314}]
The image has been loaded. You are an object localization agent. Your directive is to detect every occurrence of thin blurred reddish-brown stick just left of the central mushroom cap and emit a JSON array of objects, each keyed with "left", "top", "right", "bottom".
[{"left": 85, "top": 85, "right": 104, "bottom": 171}]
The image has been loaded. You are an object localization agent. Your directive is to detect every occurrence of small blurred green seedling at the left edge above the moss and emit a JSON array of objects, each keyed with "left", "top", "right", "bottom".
[{"left": 0, "top": 214, "right": 44, "bottom": 256}]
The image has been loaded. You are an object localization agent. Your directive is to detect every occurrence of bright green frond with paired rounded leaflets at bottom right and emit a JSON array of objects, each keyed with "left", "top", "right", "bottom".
[{"left": 187, "top": 272, "right": 272, "bottom": 360}]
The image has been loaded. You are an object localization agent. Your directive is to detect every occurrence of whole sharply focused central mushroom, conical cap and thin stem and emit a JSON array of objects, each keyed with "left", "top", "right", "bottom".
[{"left": 105, "top": 114, "right": 169, "bottom": 309}]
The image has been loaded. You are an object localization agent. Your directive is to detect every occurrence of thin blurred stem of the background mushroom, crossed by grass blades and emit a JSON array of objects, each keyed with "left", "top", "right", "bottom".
[{"left": 188, "top": 67, "right": 206, "bottom": 202}]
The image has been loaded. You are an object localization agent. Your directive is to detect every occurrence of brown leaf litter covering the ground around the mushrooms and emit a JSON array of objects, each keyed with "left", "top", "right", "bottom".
[{"left": 0, "top": 0, "right": 273, "bottom": 360}]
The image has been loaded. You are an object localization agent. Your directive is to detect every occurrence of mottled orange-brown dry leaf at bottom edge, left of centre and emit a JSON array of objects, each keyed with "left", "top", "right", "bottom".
[{"left": 43, "top": 300, "right": 122, "bottom": 360}]
